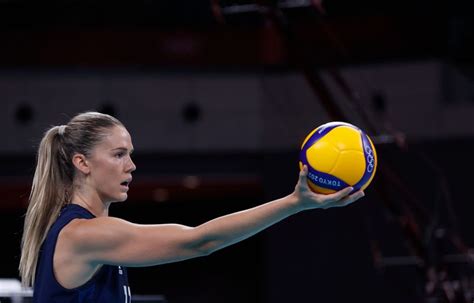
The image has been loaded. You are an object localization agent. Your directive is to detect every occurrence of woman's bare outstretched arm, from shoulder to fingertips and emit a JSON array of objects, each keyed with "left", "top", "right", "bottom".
[{"left": 63, "top": 168, "right": 364, "bottom": 266}]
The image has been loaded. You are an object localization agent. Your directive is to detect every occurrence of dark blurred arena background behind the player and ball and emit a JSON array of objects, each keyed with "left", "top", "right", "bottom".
[{"left": 0, "top": 0, "right": 474, "bottom": 303}]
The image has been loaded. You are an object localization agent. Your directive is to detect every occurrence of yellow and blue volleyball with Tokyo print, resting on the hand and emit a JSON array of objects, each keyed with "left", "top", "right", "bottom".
[{"left": 299, "top": 122, "right": 377, "bottom": 194}]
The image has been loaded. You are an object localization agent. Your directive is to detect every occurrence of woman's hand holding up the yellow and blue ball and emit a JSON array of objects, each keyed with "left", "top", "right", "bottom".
[{"left": 292, "top": 165, "right": 364, "bottom": 210}]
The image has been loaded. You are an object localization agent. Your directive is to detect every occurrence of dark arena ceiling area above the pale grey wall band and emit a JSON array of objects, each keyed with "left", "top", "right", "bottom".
[{"left": 0, "top": 0, "right": 474, "bottom": 68}]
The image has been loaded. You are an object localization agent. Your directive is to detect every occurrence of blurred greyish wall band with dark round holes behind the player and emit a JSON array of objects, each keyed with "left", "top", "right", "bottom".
[{"left": 0, "top": 61, "right": 474, "bottom": 153}]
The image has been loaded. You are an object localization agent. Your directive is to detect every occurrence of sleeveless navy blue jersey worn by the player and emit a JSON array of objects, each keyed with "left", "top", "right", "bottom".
[{"left": 33, "top": 204, "right": 131, "bottom": 303}]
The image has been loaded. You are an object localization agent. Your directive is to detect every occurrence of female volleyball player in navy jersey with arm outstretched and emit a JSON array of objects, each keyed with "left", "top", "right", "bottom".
[{"left": 19, "top": 112, "right": 364, "bottom": 303}]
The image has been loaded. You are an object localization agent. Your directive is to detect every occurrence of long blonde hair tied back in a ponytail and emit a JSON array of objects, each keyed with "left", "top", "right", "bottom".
[{"left": 19, "top": 112, "right": 123, "bottom": 286}]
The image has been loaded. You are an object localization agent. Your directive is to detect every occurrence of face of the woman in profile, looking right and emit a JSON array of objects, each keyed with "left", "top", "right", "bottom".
[{"left": 87, "top": 126, "right": 136, "bottom": 203}]
